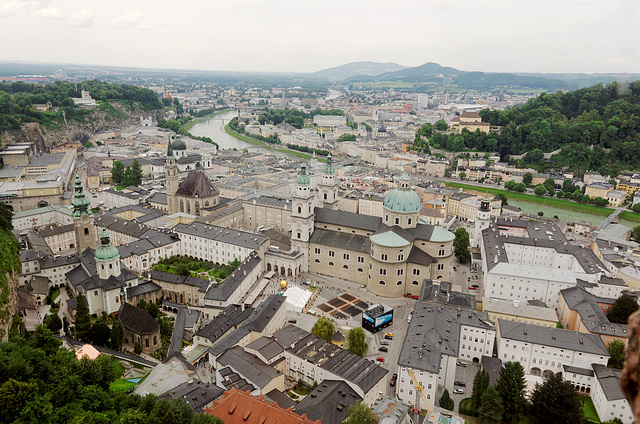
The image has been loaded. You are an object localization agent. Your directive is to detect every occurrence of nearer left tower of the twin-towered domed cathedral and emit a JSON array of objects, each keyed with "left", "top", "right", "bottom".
[{"left": 291, "top": 164, "right": 314, "bottom": 272}]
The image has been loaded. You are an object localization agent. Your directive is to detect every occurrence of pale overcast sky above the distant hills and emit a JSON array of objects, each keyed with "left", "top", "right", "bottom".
[{"left": 0, "top": 0, "right": 640, "bottom": 73}]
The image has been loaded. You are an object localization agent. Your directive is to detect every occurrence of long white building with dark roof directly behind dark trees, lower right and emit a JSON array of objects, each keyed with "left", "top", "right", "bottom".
[{"left": 496, "top": 319, "right": 609, "bottom": 377}]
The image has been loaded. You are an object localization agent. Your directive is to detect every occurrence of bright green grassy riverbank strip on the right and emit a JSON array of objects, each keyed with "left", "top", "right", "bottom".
[{"left": 445, "top": 182, "right": 640, "bottom": 222}]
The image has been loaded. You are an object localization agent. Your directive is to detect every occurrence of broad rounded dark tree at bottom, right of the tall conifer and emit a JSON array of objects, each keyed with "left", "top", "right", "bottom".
[{"left": 531, "top": 374, "right": 584, "bottom": 424}]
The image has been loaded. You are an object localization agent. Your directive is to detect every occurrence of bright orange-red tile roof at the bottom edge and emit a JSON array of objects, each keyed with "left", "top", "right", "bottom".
[{"left": 204, "top": 388, "right": 320, "bottom": 424}]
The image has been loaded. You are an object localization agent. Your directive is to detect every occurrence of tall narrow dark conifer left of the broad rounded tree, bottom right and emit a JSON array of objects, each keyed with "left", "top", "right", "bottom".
[{"left": 496, "top": 362, "right": 527, "bottom": 422}]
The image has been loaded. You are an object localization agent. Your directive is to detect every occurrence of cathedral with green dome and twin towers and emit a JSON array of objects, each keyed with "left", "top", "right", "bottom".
[{"left": 291, "top": 161, "right": 454, "bottom": 297}]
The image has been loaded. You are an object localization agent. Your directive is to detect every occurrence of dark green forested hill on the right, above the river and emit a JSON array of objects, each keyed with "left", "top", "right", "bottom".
[{"left": 431, "top": 81, "right": 640, "bottom": 175}]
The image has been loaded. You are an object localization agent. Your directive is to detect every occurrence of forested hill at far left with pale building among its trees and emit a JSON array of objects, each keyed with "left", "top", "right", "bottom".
[{"left": 0, "top": 80, "right": 163, "bottom": 131}]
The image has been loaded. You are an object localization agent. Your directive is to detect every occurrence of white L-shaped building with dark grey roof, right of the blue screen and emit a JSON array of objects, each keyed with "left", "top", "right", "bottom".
[{"left": 396, "top": 302, "right": 496, "bottom": 408}]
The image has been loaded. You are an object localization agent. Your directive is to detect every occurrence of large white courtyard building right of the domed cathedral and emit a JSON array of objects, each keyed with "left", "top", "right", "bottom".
[{"left": 480, "top": 218, "right": 606, "bottom": 309}]
